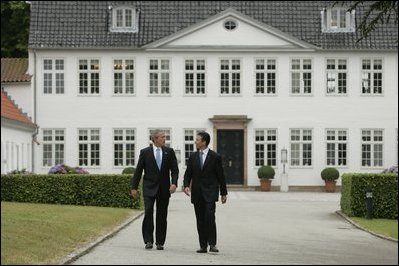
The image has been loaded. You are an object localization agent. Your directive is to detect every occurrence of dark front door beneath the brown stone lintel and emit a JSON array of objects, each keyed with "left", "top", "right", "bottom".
[{"left": 217, "top": 129, "right": 244, "bottom": 185}]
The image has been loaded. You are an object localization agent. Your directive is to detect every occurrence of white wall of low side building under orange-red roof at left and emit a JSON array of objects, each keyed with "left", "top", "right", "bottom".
[{"left": 1, "top": 126, "right": 32, "bottom": 174}]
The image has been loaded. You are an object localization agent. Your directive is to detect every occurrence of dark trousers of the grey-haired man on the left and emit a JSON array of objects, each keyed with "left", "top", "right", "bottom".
[{"left": 142, "top": 193, "right": 169, "bottom": 245}]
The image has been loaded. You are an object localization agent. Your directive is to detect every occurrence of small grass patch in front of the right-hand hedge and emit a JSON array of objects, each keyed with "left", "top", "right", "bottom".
[{"left": 351, "top": 217, "right": 398, "bottom": 239}]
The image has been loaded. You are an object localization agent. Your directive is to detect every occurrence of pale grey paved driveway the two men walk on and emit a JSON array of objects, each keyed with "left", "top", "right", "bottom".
[{"left": 70, "top": 191, "right": 398, "bottom": 265}]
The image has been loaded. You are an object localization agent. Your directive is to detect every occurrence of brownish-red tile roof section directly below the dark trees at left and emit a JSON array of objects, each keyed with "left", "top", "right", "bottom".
[{"left": 1, "top": 58, "right": 32, "bottom": 83}]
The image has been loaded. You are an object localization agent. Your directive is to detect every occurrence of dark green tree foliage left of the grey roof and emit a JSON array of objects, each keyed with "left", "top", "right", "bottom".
[{"left": 1, "top": 1, "right": 30, "bottom": 58}]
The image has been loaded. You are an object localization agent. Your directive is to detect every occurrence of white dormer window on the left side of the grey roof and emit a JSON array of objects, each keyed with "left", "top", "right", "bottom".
[{"left": 109, "top": 6, "right": 138, "bottom": 32}]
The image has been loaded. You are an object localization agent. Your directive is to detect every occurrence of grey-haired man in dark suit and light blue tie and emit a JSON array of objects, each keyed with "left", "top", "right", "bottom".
[{"left": 131, "top": 130, "right": 179, "bottom": 250}]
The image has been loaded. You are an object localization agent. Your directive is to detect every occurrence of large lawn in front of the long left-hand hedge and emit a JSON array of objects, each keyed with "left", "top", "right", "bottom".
[{"left": 1, "top": 202, "right": 139, "bottom": 265}]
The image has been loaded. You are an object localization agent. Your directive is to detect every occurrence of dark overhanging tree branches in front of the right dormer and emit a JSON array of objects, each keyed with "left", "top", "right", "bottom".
[{"left": 333, "top": 1, "right": 398, "bottom": 42}]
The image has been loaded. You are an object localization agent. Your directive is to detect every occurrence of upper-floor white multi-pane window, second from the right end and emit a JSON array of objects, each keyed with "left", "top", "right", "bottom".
[{"left": 327, "top": 59, "right": 348, "bottom": 95}]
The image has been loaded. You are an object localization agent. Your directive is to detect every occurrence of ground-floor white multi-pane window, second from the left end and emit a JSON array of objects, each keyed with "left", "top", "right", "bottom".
[{"left": 78, "top": 129, "right": 100, "bottom": 166}]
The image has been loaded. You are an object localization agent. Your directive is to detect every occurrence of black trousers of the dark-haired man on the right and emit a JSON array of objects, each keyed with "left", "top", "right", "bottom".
[{"left": 194, "top": 194, "right": 216, "bottom": 249}]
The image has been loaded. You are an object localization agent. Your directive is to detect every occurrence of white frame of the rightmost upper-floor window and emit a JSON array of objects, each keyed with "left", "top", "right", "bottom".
[{"left": 360, "top": 58, "right": 385, "bottom": 96}]
